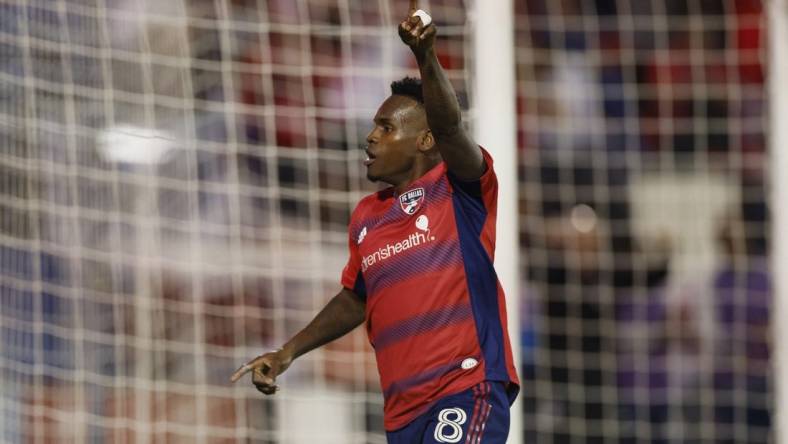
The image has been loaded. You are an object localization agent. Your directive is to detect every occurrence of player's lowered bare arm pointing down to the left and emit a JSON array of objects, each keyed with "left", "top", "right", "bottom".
[{"left": 230, "top": 288, "right": 365, "bottom": 395}]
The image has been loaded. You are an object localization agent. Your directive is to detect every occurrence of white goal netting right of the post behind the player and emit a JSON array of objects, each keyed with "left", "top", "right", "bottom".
[{"left": 515, "top": 0, "right": 772, "bottom": 443}]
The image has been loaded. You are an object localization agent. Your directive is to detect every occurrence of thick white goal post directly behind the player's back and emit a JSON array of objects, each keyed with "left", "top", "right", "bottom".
[{"left": 471, "top": 0, "right": 529, "bottom": 444}]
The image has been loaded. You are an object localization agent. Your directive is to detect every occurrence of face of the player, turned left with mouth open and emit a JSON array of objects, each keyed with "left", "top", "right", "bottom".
[{"left": 364, "top": 96, "right": 427, "bottom": 185}]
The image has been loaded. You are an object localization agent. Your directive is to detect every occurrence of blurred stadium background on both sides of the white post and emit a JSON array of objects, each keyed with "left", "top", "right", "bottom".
[{"left": 0, "top": 0, "right": 774, "bottom": 443}]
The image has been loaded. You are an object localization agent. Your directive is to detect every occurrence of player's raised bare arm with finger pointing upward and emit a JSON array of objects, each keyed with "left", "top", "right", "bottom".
[{"left": 399, "top": 0, "right": 486, "bottom": 180}]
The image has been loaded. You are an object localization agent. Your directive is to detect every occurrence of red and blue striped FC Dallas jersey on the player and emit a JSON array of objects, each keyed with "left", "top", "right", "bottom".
[{"left": 342, "top": 150, "right": 519, "bottom": 430}]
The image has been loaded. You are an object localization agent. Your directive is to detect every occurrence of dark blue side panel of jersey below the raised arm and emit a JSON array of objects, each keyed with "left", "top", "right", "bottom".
[{"left": 452, "top": 177, "right": 509, "bottom": 381}]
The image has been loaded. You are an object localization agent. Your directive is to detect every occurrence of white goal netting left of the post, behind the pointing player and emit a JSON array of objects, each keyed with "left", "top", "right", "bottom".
[{"left": 0, "top": 0, "right": 474, "bottom": 443}]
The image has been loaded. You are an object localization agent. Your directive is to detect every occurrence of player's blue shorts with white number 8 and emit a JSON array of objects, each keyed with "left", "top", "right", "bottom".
[{"left": 386, "top": 382, "right": 509, "bottom": 444}]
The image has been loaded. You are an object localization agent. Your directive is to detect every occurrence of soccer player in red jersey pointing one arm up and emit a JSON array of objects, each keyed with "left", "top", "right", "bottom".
[{"left": 231, "top": 0, "right": 519, "bottom": 444}]
